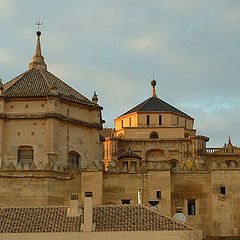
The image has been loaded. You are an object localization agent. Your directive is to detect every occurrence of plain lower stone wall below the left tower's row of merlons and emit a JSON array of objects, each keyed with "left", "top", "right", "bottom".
[{"left": 0, "top": 170, "right": 102, "bottom": 207}]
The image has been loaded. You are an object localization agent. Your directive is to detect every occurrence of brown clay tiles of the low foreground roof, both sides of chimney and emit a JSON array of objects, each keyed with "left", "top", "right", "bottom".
[{"left": 0, "top": 205, "right": 192, "bottom": 233}]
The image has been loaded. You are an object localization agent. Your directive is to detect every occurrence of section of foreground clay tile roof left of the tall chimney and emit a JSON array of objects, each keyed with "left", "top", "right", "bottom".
[{"left": 0, "top": 207, "right": 83, "bottom": 233}]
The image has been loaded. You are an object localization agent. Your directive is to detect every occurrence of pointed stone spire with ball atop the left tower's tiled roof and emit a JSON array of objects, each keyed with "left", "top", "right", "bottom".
[{"left": 29, "top": 31, "right": 47, "bottom": 69}]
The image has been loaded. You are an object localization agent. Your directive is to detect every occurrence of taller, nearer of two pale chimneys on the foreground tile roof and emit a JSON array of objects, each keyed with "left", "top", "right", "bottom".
[{"left": 82, "top": 192, "right": 93, "bottom": 232}]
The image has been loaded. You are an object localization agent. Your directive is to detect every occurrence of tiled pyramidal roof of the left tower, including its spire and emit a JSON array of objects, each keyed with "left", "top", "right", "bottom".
[{"left": 1, "top": 31, "right": 100, "bottom": 108}]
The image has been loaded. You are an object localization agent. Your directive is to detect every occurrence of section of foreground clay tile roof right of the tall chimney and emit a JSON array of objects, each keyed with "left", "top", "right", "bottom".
[{"left": 95, "top": 205, "right": 191, "bottom": 231}]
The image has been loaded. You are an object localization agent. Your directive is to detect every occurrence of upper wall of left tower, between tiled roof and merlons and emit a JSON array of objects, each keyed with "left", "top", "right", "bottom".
[{"left": 0, "top": 97, "right": 101, "bottom": 168}]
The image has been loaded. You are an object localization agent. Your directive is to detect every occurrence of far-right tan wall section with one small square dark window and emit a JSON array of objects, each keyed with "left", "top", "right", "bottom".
[{"left": 211, "top": 169, "right": 240, "bottom": 236}]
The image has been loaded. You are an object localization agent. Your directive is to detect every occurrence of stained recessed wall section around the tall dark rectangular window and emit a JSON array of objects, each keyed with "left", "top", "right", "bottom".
[{"left": 171, "top": 172, "right": 213, "bottom": 234}]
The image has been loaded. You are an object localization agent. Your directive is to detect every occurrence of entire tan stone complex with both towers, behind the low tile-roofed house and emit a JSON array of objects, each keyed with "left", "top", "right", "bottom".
[{"left": 0, "top": 32, "right": 240, "bottom": 239}]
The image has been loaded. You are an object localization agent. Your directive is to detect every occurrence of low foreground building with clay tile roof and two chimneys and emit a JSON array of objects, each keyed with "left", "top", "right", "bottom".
[{"left": 0, "top": 192, "right": 199, "bottom": 240}]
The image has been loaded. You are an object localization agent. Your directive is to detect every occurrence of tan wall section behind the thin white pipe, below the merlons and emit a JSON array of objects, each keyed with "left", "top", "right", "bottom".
[{"left": 103, "top": 171, "right": 171, "bottom": 216}]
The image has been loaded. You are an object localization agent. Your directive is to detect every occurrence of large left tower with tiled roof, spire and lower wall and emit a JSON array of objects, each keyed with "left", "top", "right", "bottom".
[{"left": 0, "top": 31, "right": 103, "bottom": 206}]
